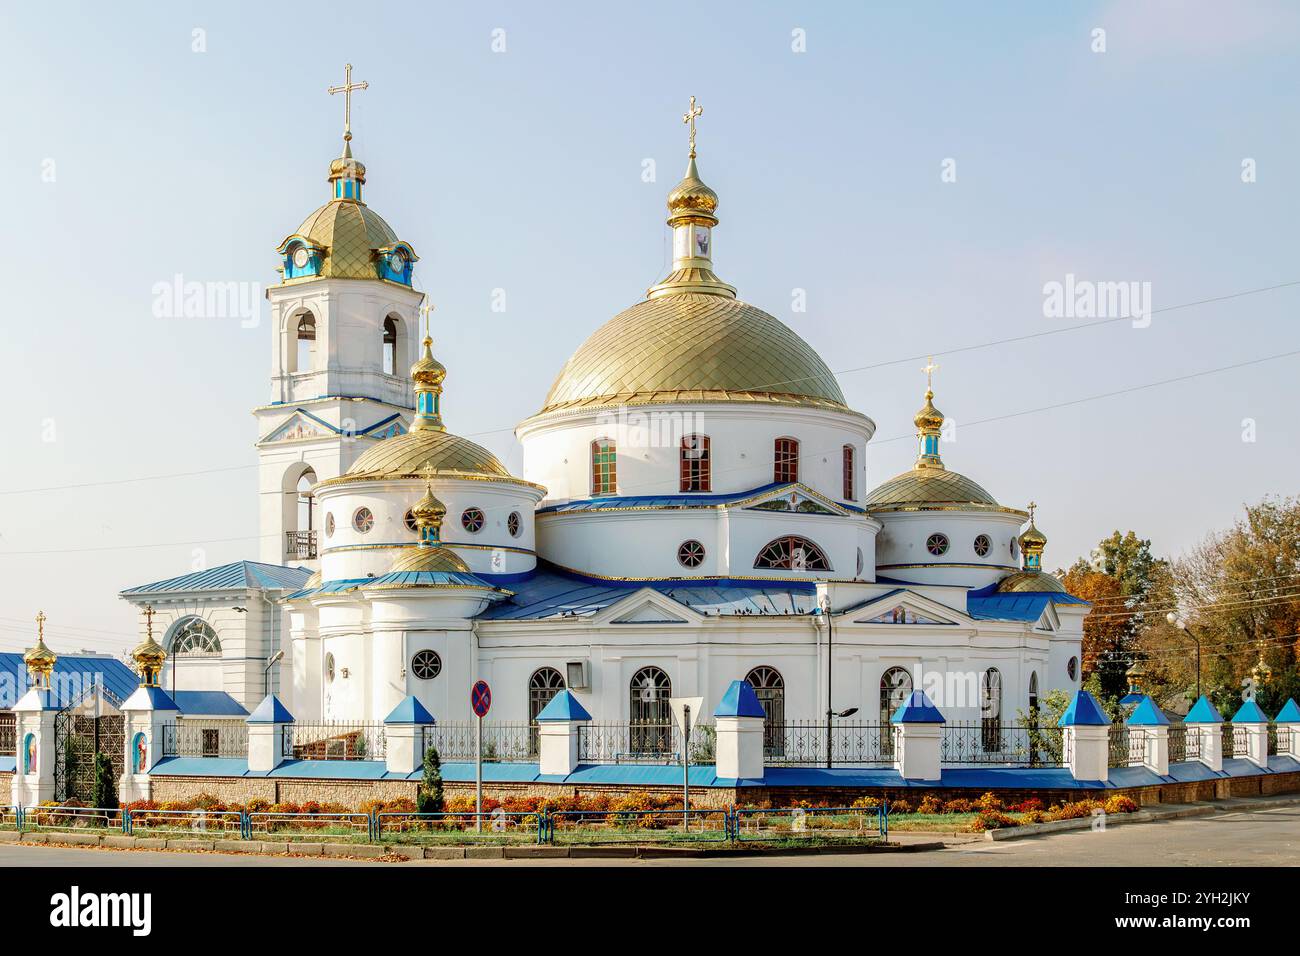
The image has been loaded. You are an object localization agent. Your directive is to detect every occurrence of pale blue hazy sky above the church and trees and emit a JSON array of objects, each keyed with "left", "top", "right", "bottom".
[{"left": 0, "top": 1, "right": 1300, "bottom": 650}]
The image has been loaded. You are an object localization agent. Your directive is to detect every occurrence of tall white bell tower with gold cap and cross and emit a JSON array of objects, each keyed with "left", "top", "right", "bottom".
[{"left": 254, "top": 64, "right": 424, "bottom": 568}]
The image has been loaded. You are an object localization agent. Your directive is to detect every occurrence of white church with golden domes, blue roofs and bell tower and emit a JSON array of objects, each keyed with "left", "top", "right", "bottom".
[{"left": 122, "top": 79, "right": 1088, "bottom": 738}]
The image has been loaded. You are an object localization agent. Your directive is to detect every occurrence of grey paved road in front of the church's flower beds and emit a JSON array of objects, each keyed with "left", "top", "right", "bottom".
[{"left": 0, "top": 806, "right": 1300, "bottom": 868}]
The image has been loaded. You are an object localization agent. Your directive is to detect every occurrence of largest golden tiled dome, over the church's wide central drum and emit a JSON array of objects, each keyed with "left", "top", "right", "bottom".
[{"left": 540, "top": 293, "right": 849, "bottom": 414}]
